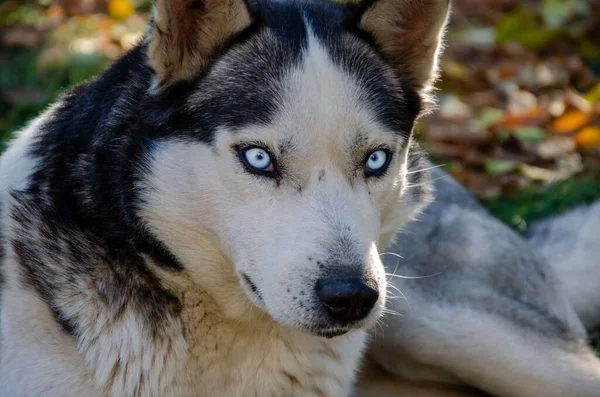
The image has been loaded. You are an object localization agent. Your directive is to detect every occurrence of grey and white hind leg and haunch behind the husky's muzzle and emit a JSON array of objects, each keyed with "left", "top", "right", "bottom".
[{"left": 371, "top": 168, "right": 600, "bottom": 397}]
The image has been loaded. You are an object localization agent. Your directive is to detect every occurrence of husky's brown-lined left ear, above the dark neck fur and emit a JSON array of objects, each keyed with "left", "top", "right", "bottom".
[{"left": 147, "top": 0, "right": 252, "bottom": 88}]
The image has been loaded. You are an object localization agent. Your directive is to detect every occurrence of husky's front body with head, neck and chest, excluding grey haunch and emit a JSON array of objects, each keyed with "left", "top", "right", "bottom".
[{"left": 0, "top": 0, "right": 449, "bottom": 397}]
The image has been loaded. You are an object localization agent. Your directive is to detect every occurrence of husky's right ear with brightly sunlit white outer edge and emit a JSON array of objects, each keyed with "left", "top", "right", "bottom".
[{"left": 349, "top": 0, "right": 450, "bottom": 98}]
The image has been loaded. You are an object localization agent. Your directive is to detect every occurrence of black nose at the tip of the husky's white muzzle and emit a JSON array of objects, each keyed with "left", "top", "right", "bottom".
[{"left": 317, "top": 278, "right": 379, "bottom": 325}]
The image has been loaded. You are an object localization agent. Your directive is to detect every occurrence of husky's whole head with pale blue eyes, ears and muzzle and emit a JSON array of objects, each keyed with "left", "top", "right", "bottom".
[{"left": 140, "top": 0, "right": 449, "bottom": 336}]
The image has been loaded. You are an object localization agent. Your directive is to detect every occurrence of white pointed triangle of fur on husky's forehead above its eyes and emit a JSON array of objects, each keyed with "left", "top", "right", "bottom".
[{"left": 265, "top": 24, "right": 406, "bottom": 157}]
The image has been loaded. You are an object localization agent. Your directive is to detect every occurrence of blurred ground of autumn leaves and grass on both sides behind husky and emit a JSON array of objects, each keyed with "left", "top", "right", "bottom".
[{"left": 0, "top": 0, "right": 600, "bottom": 231}]
